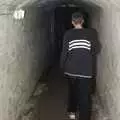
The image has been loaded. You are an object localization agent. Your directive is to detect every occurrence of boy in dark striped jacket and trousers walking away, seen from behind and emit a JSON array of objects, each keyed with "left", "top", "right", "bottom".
[{"left": 61, "top": 12, "right": 97, "bottom": 120}]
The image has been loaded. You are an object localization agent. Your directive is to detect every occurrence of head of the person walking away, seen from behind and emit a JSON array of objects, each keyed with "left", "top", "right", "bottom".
[{"left": 72, "top": 12, "right": 84, "bottom": 27}]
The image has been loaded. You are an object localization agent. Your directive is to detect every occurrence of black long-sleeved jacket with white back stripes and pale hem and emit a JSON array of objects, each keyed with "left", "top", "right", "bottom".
[{"left": 61, "top": 29, "right": 98, "bottom": 78}]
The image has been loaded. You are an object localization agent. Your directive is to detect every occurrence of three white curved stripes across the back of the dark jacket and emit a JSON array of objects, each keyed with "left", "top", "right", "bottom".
[{"left": 69, "top": 40, "right": 91, "bottom": 51}]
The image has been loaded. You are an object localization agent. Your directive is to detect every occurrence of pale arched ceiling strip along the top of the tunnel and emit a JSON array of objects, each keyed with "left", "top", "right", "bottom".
[{"left": 0, "top": 0, "right": 120, "bottom": 13}]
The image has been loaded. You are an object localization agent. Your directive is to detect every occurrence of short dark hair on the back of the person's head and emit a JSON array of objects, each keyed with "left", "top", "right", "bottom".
[{"left": 72, "top": 12, "right": 84, "bottom": 24}]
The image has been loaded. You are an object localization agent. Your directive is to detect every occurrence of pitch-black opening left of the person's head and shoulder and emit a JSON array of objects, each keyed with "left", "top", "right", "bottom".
[{"left": 55, "top": 7, "right": 79, "bottom": 60}]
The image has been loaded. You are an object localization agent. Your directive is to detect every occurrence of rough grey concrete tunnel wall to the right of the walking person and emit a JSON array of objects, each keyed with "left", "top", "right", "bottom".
[{"left": 89, "top": 3, "right": 120, "bottom": 120}]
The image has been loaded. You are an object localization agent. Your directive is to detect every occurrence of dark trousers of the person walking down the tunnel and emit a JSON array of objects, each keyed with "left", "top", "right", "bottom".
[{"left": 68, "top": 78, "right": 90, "bottom": 120}]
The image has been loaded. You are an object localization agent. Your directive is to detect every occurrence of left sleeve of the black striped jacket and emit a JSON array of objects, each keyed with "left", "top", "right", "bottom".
[{"left": 60, "top": 34, "right": 69, "bottom": 68}]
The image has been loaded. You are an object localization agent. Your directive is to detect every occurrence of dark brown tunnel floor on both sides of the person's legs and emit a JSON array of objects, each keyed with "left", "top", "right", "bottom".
[{"left": 21, "top": 67, "right": 110, "bottom": 120}]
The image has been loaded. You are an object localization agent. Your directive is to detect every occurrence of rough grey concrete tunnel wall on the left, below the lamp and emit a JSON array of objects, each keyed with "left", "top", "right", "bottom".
[{"left": 0, "top": 7, "right": 52, "bottom": 120}]
